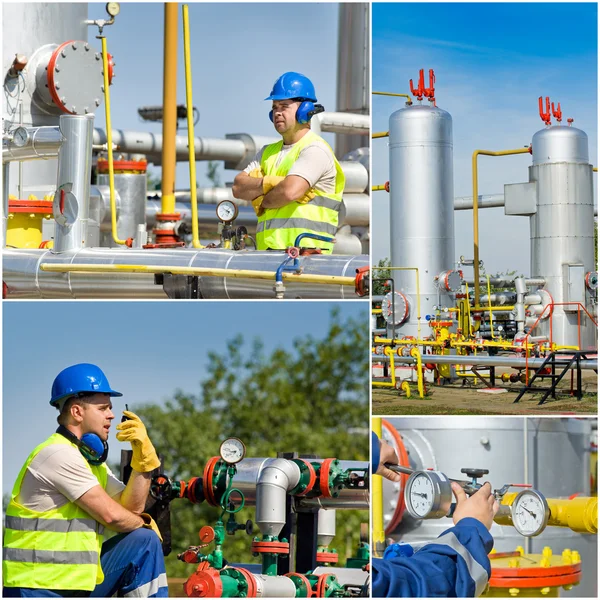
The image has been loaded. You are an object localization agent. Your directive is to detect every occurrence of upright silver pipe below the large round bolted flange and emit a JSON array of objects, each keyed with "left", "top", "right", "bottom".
[{"left": 53, "top": 114, "right": 94, "bottom": 252}]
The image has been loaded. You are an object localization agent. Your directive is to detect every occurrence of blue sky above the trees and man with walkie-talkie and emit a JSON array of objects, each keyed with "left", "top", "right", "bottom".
[{"left": 2, "top": 301, "right": 369, "bottom": 492}]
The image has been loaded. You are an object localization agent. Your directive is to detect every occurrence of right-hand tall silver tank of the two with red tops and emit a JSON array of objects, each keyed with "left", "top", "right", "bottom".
[{"left": 529, "top": 126, "right": 597, "bottom": 350}]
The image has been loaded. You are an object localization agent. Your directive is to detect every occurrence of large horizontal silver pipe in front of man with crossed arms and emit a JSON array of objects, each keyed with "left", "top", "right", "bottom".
[{"left": 3, "top": 248, "right": 369, "bottom": 299}]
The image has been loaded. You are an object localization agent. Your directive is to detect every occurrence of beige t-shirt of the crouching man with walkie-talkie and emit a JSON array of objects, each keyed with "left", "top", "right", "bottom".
[{"left": 17, "top": 444, "right": 125, "bottom": 512}]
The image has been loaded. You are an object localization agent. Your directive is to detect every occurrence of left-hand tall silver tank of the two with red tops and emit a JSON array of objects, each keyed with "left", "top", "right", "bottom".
[{"left": 389, "top": 105, "right": 454, "bottom": 336}]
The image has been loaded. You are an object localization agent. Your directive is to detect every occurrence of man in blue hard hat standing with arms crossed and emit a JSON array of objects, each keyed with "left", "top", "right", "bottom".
[{"left": 233, "top": 71, "right": 345, "bottom": 254}]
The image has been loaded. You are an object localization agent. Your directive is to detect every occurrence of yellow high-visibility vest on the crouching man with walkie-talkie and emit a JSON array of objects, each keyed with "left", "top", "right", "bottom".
[{"left": 2, "top": 433, "right": 108, "bottom": 591}]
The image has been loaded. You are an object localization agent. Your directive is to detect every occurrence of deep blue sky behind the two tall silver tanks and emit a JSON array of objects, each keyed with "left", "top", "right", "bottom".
[{"left": 372, "top": 2, "right": 598, "bottom": 275}]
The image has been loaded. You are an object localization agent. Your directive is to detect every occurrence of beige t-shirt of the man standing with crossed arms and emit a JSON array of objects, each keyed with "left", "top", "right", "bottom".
[{"left": 244, "top": 137, "right": 336, "bottom": 194}]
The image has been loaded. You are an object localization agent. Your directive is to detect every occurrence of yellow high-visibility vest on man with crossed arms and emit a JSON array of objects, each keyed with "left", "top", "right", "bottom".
[{"left": 256, "top": 131, "right": 346, "bottom": 254}]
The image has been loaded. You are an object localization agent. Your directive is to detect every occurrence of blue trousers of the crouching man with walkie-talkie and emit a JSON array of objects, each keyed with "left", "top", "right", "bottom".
[{"left": 2, "top": 529, "right": 169, "bottom": 598}]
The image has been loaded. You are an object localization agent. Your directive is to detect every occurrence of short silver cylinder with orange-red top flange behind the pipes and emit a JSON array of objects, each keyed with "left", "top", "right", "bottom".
[{"left": 97, "top": 159, "right": 148, "bottom": 247}]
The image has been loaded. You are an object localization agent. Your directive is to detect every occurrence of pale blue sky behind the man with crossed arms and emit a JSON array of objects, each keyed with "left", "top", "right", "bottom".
[{"left": 88, "top": 2, "right": 338, "bottom": 189}]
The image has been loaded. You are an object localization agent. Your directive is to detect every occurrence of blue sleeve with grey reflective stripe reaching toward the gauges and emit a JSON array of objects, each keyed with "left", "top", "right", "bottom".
[{"left": 372, "top": 518, "right": 494, "bottom": 598}]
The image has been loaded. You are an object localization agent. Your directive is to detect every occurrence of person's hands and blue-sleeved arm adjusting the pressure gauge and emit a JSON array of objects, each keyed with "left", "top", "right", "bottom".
[{"left": 371, "top": 433, "right": 498, "bottom": 598}]
